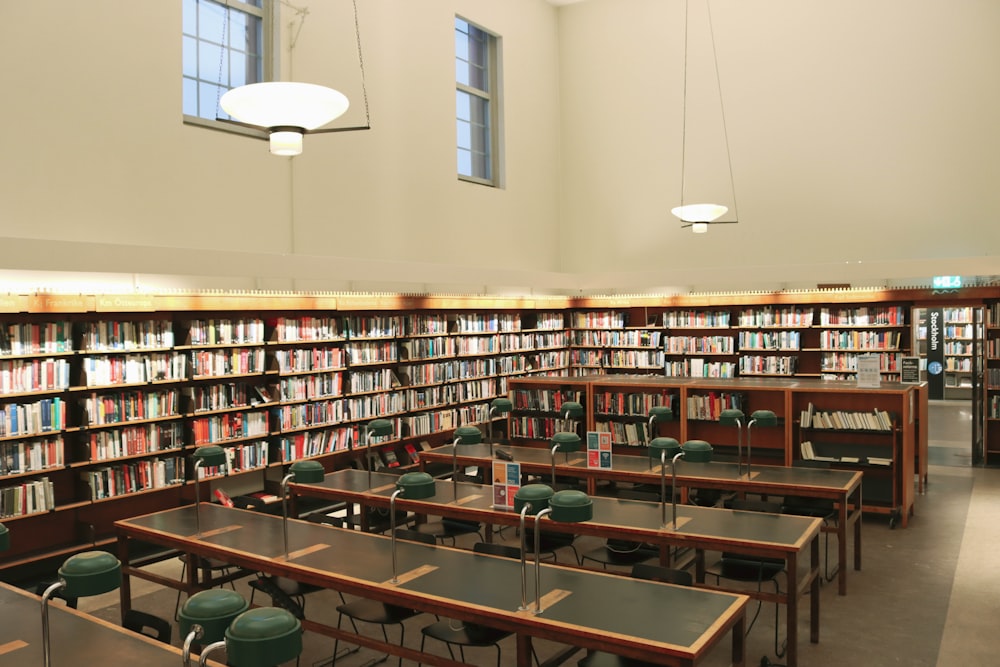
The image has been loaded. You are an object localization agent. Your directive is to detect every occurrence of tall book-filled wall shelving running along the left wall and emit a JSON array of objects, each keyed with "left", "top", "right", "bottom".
[{"left": 0, "top": 295, "right": 570, "bottom": 569}]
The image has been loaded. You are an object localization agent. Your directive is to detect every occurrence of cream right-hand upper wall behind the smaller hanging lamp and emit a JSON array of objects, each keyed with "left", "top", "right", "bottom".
[{"left": 560, "top": 0, "right": 1000, "bottom": 291}]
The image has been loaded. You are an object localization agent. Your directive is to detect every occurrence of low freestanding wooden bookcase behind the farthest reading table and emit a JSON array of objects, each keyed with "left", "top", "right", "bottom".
[{"left": 511, "top": 375, "right": 927, "bottom": 517}]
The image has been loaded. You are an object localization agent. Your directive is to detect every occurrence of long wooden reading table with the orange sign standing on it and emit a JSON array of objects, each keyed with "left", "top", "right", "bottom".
[{"left": 289, "top": 469, "right": 822, "bottom": 665}]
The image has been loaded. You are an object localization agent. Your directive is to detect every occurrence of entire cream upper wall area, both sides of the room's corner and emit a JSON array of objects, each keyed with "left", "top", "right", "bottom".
[{"left": 0, "top": 0, "right": 1000, "bottom": 293}]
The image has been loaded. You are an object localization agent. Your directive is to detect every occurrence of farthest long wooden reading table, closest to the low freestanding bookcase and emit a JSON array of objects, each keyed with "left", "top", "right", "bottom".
[{"left": 420, "top": 444, "right": 862, "bottom": 595}]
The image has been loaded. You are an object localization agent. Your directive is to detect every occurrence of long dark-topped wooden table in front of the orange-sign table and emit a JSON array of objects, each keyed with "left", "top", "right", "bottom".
[{"left": 115, "top": 504, "right": 748, "bottom": 667}]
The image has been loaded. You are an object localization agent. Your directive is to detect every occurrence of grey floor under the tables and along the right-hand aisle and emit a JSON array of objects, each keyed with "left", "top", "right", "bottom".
[{"left": 68, "top": 402, "right": 1000, "bottom": 667}]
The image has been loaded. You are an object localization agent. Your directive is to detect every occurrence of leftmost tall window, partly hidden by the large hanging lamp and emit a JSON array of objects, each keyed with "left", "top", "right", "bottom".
[{"left": 183, "top": 0, "right": 271, "bottom": 121}]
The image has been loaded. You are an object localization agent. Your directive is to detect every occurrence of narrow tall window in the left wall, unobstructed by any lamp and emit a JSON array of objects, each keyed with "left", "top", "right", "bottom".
[{"left": 455, "top": 17, "right": 500, "bottom": 185}]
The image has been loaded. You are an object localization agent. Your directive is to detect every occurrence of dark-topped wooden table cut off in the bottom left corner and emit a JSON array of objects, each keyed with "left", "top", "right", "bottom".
[{"left": 0, "top": 583, "right": 222, "bottom": 667}]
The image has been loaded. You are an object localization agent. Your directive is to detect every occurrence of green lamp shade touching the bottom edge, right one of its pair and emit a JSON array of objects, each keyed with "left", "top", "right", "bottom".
[{"left": 226, "top": 607, "right": 302, "bottom": 667}]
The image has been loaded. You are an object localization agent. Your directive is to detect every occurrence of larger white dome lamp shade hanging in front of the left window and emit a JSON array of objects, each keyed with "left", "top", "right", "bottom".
[{"left": 219, "top": 81, "right": 350, "bottom": 156}]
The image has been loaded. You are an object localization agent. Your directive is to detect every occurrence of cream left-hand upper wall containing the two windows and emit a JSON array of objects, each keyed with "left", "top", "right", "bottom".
[{"left": 0, "top": 0, "right": 566, "bottom": 292}]
